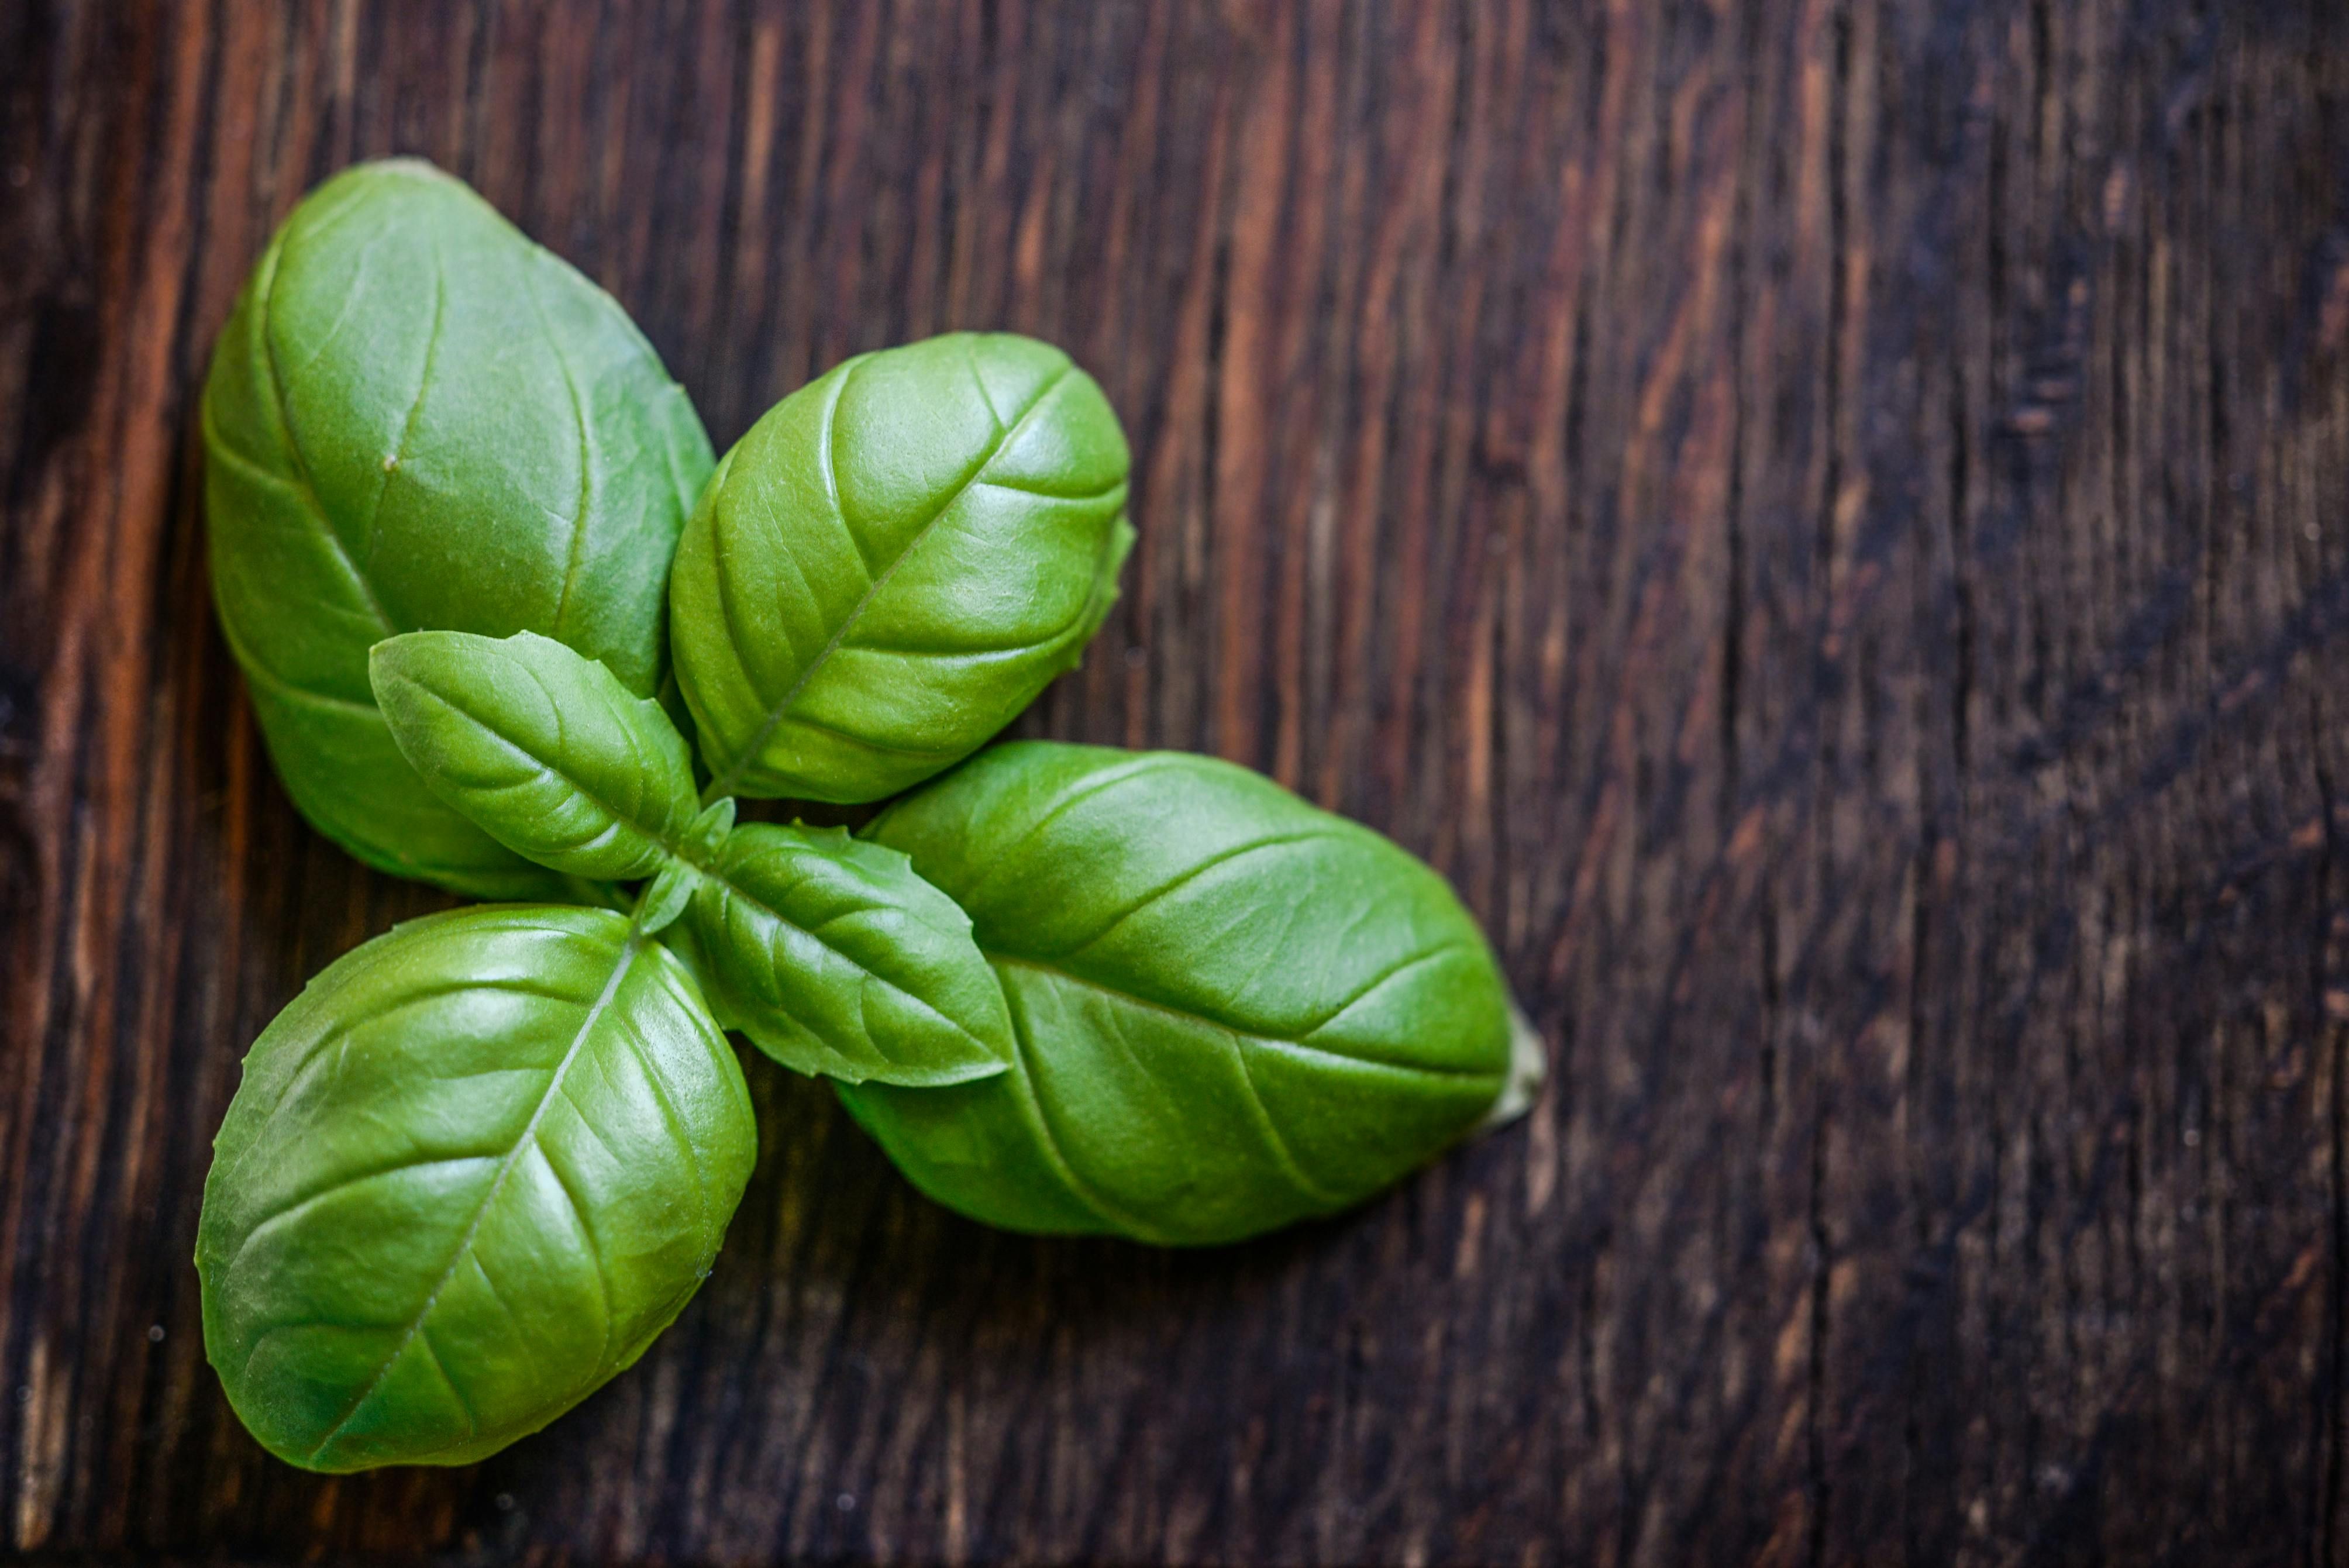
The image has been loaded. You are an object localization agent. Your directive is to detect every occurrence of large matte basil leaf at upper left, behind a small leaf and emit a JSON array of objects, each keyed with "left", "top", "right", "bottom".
[{"left": 202, "top": 160, "right": 709, "bottom": 897}]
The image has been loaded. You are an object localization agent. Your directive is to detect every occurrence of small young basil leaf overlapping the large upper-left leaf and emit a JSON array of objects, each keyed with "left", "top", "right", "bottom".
[{"left": 369, "top": 632, "right": 698, "bottom": 883}]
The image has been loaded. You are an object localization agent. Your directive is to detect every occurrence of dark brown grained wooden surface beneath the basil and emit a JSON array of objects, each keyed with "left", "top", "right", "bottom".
[{"left": 0, "top": 0, "right": 2349, "bottom": 1563}]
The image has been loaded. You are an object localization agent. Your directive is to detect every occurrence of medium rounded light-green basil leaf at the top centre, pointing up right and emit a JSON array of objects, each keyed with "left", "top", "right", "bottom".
[{"left": 670, "top": 333, "right": 1132, "bottom": 801}]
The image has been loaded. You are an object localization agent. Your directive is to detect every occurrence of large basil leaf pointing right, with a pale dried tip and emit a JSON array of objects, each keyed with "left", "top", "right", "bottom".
[{"left": 841, "top": 742, "right": 1513, "bottom": 1244}]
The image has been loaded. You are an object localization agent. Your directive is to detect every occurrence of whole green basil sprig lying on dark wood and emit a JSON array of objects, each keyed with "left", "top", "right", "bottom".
[{"left": 197, "top": 160, "right": 1538, "bottom": 1471}]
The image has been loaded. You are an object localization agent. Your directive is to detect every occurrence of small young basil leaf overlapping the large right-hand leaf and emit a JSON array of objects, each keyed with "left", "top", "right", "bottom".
[{"left": 684, "top": 824, "right": 1012, "bottom": 1084}]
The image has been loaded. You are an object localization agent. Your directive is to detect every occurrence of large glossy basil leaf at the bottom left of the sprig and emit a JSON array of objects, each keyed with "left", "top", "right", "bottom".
[{"left": 195, "top": 906, "right": 756, "bottom": 1471}]
